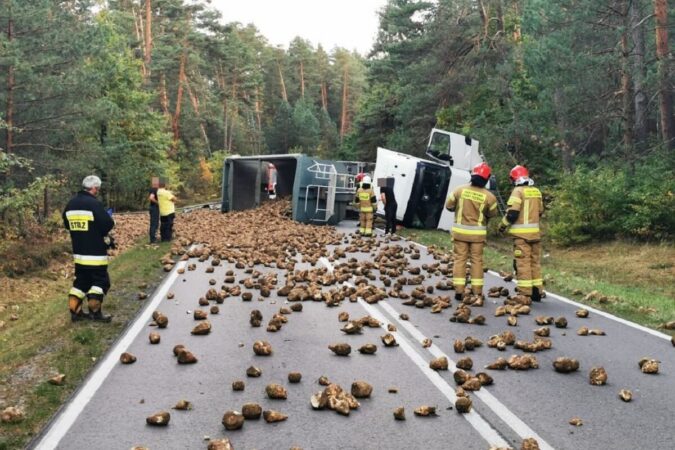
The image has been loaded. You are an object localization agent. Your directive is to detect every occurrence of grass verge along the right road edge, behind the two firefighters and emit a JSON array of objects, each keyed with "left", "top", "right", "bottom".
[{"left": 401, "top": 229, "right": 675, "bottom": 334}]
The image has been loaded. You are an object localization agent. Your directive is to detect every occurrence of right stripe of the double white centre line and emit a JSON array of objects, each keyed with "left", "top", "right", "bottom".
[{"left": 378, "top": 301, "right": 553, "bottom": 450}]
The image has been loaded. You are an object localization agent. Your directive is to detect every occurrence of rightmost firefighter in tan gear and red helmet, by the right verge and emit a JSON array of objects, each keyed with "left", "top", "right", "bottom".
[{"left": 499, "top": 166, "right": 544, "bottom": 302}]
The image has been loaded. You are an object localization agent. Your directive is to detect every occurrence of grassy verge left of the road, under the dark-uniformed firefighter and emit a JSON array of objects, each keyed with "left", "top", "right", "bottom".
[{"left": 0, "top": 244, "right": 169, "bottom": 450}]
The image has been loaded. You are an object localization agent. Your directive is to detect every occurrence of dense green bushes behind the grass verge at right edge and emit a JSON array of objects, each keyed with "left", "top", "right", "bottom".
[{"left": 548, "top": 157, "right": 675, "bottom": 245}]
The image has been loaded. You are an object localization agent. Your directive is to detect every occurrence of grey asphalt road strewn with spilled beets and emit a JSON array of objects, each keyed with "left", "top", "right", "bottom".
[{"left": 33, "top": 223, "right": 675, "bottom": 450}]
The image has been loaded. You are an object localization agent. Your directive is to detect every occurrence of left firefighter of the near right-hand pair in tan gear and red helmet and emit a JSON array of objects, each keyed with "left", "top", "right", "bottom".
[{"left": 445, "top": 163, "right": 497, "bottom": 300}]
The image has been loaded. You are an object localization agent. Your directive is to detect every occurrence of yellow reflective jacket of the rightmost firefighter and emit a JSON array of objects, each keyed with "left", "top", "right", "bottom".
[{"left": 502, "top": 186, "right": 544, "bottom": 241}]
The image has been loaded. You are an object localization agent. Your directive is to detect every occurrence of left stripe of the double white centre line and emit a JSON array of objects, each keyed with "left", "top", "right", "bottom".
[{"left": 358, "top": 299, "right": 511, "bottom": 448}]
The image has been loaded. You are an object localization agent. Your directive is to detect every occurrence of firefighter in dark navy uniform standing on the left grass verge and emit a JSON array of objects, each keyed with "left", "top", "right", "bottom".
[{"left": 62, "top": 175, "right": 115, "bottom": 322}]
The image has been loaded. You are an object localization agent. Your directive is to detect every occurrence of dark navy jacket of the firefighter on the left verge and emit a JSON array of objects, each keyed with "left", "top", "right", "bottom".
[{"left": 62, "top": 191, "right": 115, "bottom": 267}]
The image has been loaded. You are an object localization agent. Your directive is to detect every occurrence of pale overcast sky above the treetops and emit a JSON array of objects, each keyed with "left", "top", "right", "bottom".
[{"left": 211, "top": 0, "right": 386, "bottom": 55}]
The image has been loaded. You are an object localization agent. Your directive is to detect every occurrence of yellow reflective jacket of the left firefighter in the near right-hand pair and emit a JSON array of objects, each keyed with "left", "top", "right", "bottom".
[{"left": 445, "top": 184, "right": 497, "bottom": 242}]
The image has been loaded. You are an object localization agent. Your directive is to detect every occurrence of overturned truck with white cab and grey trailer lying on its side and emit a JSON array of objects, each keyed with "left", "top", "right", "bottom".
[{"left": 221, "top": 129, "right": 501, "bottom": 230}]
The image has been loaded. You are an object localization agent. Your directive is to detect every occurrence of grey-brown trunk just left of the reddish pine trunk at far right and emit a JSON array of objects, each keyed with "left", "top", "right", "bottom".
[{"left": 629, "top": 0, "right": 648, "bottom": 153}]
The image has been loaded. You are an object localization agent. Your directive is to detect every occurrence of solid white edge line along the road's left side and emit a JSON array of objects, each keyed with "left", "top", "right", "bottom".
[{"left": 35, "top": 261, "right": 187, "bottom": 450}]
